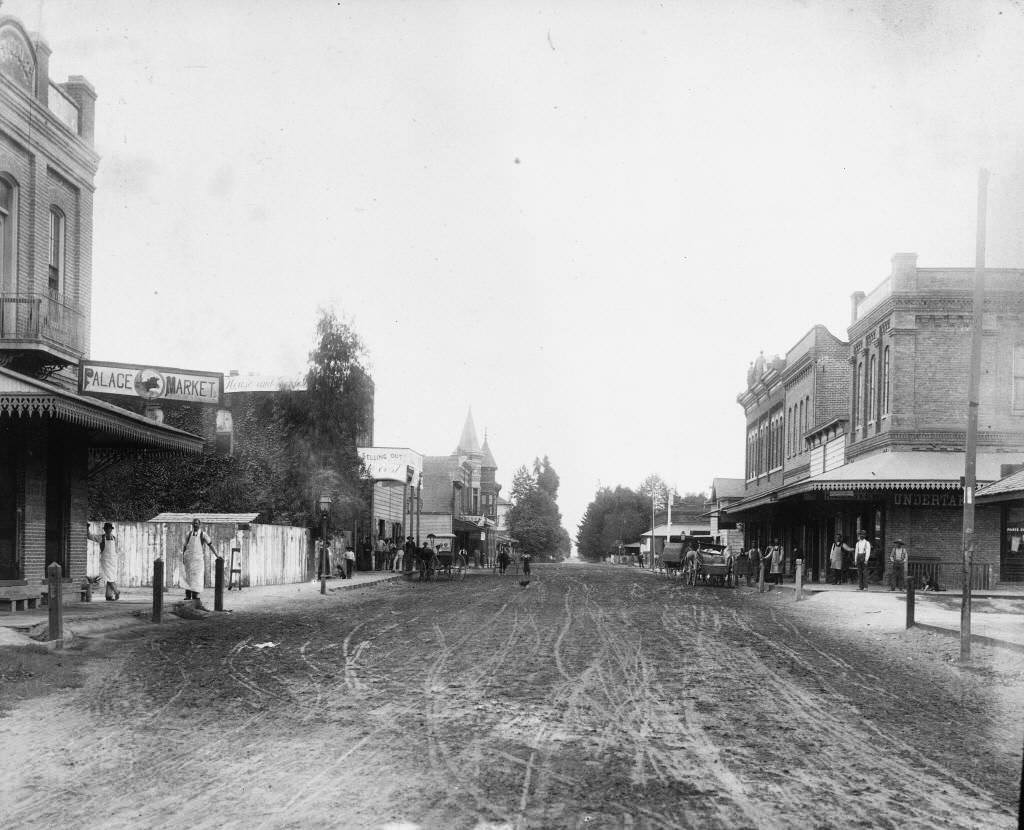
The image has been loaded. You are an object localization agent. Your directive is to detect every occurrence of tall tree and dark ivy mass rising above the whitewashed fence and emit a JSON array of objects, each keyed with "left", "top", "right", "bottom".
[{"left": 89, "top": 311, "right": 373, "bottom": 526}]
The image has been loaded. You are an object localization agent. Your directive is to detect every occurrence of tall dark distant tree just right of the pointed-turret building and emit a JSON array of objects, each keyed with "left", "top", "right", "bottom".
[{"left": 508, "top": 456, "right": 571, "bottom": 561}]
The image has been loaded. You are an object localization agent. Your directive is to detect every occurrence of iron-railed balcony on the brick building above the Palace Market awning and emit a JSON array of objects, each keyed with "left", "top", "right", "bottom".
[{"left": 0, "top": 294, "right": 85, "bottom": 356}]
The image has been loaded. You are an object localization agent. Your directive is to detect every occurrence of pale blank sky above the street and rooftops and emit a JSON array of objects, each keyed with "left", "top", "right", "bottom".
[{"left": 12, "top": 0, "right": 1024, "bottom": 536}]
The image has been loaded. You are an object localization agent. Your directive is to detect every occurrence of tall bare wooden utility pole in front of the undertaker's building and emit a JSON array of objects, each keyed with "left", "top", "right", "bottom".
[{"left": 961, "top": 169, "right": 988, "bottom": 662}]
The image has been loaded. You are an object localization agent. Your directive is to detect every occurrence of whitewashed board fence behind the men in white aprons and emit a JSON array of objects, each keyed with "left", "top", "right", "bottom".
[{"left": 86, "top": 522, "right": 311, "bottom": 587}]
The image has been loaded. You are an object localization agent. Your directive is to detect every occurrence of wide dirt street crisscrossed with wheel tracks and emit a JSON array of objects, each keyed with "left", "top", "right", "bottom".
[{"left": 0, "top": 565, "right": 1024, "bottom": 830}]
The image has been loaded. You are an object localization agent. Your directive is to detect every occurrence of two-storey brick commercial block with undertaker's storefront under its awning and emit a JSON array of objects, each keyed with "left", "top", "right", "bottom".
[{"left": 729, "top": 254, "right": 1024, "bottom": 584}]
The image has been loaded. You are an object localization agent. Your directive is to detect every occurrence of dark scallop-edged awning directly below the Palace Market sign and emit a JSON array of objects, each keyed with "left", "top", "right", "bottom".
[{"left": 0, "top": 367, "right": 203, "bottom": 454}]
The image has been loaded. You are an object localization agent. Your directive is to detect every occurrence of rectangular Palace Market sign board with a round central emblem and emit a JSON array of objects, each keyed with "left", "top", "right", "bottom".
[{"left": 78, "top": 360, "right": 224, "bottom": 405}]
